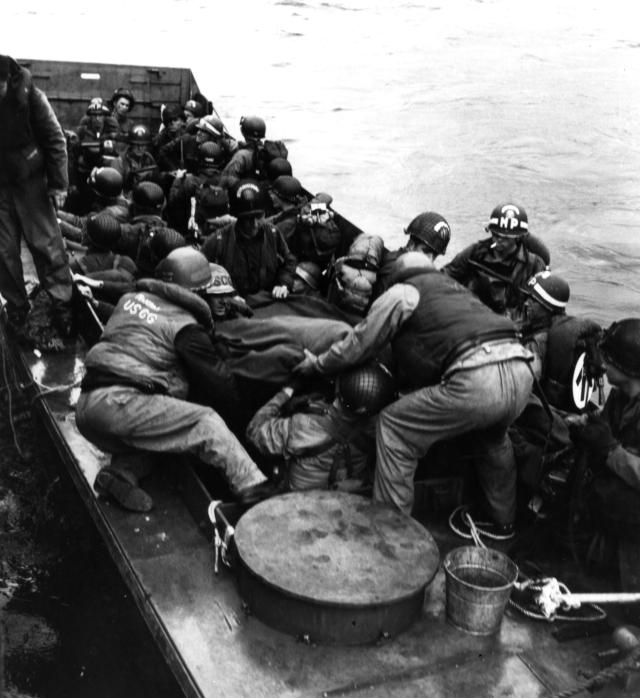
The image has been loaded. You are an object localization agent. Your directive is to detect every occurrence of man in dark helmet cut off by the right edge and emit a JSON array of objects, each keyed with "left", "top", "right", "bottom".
[{"left": 571, "top": 318, "right": 640, "bottom": 580}]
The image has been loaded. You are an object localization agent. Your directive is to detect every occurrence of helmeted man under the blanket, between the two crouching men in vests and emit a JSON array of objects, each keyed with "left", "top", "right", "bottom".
[{"left": 247, "top": 362, "right": 396, "bottom": 491}]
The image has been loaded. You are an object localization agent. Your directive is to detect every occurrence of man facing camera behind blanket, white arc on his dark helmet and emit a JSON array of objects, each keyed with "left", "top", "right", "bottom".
[{"left": 202, "top": 180, "right": 296, "bottom": 299}]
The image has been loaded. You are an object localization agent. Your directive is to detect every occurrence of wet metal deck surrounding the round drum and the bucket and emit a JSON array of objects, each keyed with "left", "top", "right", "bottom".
[{"left": 0, "top": 329, "right": 620, "bottom": 698}]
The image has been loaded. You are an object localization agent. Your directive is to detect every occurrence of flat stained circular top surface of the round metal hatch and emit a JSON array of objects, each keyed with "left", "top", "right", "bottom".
[{"left": 235, "top": 490, "right": 439, "bottom": 606}]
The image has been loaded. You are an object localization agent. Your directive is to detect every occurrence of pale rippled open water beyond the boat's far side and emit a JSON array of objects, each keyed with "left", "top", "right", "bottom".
[{"left": 2, "top": 0, "right": 640, "bottom": 322}]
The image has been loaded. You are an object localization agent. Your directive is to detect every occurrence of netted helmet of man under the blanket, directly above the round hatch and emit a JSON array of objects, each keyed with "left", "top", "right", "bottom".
[{"left": 336, "top": 361, "right": 396, "bottom": 415}]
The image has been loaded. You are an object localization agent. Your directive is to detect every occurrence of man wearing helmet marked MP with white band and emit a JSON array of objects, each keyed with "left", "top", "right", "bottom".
[{"left": 444, "top": 203, "right": 548, "bottom": 320}]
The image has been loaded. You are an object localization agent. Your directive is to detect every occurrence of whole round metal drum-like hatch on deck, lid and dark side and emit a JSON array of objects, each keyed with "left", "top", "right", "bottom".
[{"left": 235, "top": 491, "right": 439, "bottom": 644}]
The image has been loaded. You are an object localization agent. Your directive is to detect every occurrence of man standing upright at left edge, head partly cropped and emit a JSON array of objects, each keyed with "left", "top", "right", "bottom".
[{"left": 0, "top": 56, "right": 72, "bottom": 338}]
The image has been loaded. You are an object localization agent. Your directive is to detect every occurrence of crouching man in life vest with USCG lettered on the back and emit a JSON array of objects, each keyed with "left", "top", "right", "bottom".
[{"left": 76, "top": 247, "right": 273, "bottom": 511}]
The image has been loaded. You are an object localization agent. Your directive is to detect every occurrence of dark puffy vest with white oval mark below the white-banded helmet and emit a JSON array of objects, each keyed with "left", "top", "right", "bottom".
[{"left": 541, "top": 317, "right": 602, "bottom": 413}]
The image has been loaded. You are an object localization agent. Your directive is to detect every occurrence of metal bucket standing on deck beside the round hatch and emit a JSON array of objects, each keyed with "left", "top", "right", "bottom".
[{"left": 444, "top": 546, "right": 518, "bottom": 635}]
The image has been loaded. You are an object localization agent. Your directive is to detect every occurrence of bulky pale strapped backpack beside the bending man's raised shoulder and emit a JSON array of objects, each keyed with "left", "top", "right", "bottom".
[{"left": 327, "top": 233, "right": 384, "bottom": 315}]
